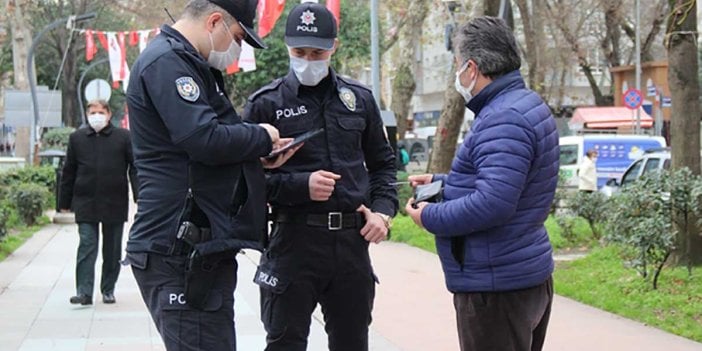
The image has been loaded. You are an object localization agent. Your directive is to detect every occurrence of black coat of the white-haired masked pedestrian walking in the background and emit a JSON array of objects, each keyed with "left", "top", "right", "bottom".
[{"left": 58, "top": 123, "right": 139, "bottom": 223}]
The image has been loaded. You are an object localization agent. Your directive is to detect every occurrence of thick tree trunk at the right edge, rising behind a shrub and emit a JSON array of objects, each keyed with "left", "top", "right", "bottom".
[{"left": 667, "top": 0, "right": 702, "bottom": 264}]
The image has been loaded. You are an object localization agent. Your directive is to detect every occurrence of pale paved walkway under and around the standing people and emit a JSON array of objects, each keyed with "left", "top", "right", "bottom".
[{"left": 0, "top": 219, "right": 702, "bottom": 351}]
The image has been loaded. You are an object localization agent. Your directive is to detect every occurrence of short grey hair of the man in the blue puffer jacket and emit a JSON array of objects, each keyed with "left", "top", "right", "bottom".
[{"left": 454, "top": 16, "right": 522, "bottom": 79}]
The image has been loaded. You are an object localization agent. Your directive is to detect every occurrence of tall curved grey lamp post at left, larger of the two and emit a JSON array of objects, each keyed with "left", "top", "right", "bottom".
[{"left": 27, "top": 12, "right": 95, "bottom": 164}]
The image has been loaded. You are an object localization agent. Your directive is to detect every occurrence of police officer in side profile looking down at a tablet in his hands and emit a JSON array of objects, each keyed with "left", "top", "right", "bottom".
[{"left": 126, "top": 0, "right": 293, "bottom": 351}]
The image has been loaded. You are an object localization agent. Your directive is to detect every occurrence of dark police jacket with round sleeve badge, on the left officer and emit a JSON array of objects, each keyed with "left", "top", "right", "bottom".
[{"left": 127, "top": 26, "right": 271, "bottom": 254}]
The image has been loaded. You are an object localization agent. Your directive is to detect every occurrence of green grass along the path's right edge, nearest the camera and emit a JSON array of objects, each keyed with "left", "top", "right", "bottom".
[{"left": 554, "top": 246, "right": 702, "bottom": 342}]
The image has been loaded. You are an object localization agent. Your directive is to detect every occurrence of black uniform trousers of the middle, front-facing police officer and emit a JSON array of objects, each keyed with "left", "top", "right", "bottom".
[{"left": 254, "top": 223, "right": 377, "bottom": 351}]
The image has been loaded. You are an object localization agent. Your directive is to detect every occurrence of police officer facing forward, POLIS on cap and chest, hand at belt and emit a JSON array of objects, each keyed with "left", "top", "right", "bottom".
[{"left": 244, "top": 3, "right": 397, "bottom": 351}]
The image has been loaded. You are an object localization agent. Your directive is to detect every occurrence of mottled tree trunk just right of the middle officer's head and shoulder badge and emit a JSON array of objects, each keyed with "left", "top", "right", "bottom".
[{"left": 390, "top": 0, "right": 429, "bottom": 140}]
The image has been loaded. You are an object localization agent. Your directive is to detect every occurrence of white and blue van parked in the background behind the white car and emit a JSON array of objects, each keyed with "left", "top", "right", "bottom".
[{"left": 559, "top": 134, "right": 666, "bottom": 188}]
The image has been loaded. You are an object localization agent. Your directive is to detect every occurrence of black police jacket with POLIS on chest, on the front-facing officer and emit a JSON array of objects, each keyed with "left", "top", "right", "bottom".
[{"left": 243, "top": 69, "right": 397, "bottom": 216}]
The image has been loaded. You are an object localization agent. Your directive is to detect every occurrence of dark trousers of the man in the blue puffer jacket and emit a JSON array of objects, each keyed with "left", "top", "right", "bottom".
[{"left": 453, "top": 277, "right": 553, "bottom": 351}]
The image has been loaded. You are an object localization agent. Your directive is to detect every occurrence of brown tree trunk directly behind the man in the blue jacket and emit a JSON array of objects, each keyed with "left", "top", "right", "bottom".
[{"left": 428, "top": 70, "right": 466, "bottom": 173}]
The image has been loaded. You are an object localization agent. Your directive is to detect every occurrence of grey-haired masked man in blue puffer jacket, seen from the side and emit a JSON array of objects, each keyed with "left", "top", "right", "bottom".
[{"left": 407, "top": 17, "right": 559, "bottom": 351}]
